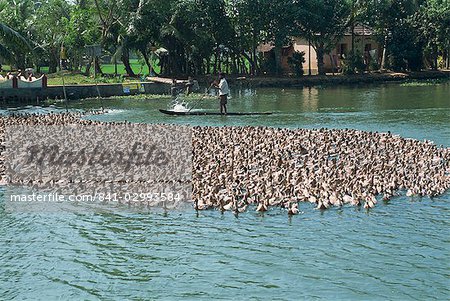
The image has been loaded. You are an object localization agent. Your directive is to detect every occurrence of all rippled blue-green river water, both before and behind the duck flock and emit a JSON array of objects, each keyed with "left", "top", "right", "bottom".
[{"left": 0, "top": 83, "right": 450, "bottom": 300}]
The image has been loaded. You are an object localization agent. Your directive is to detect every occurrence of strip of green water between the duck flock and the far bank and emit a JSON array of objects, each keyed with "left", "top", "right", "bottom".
[{"left": 65, "top": 83, "right": 450, "bottom": 146}]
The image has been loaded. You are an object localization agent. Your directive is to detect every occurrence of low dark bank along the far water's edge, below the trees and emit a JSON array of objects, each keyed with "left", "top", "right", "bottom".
[{"left": 0, "top": 71, "right": 450, "bottom": 104}]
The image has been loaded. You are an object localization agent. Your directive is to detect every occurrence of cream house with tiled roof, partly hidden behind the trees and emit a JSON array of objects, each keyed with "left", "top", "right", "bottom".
[{"left": 257, "top": 24, "right": 383, "bottom": 74}]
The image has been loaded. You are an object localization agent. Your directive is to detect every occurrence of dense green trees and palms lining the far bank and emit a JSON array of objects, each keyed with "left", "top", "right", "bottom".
[{"left": 0, "top": 0, "right": 450, "bottom": 75}]
